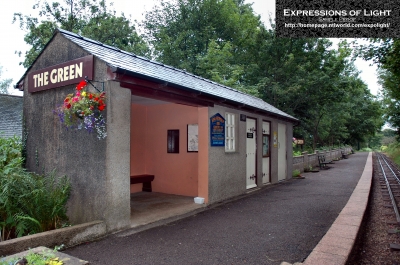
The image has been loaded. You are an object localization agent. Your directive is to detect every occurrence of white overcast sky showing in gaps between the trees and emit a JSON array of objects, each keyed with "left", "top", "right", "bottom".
[{"left": 0, "top": 0, "right": 379, "bottom": 95}]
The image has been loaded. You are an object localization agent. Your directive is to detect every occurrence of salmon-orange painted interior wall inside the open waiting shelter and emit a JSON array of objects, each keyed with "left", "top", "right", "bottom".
[{"left": 131, "top": 104, "right": 198, "bottom": 196}]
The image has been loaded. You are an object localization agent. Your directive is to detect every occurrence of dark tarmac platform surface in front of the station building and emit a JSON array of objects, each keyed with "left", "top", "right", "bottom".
[{"left": 64, "top": 153, "right": 372, "bottom": 265}]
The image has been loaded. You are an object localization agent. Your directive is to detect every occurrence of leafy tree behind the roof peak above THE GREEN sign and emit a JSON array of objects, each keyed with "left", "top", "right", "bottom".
[{"left": 13, "top": 0, "right": 150, "bottom": 68}]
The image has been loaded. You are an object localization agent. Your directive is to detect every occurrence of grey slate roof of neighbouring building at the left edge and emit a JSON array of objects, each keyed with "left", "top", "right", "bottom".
[{"left": 0, "top": 94, "right": 24, "bottom": 138}]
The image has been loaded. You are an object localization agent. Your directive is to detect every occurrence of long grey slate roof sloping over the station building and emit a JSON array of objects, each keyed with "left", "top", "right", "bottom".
[{"left": 59, "top": 29, "right": 297, "bottom": 120}]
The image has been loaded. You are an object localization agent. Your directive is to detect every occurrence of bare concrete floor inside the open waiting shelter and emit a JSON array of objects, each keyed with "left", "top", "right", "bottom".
[{"left": 131, "top": 192, "right": 206, "bottom": 228}]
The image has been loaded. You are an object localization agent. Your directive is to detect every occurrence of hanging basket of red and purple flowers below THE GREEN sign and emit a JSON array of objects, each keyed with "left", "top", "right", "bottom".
[{"left": 55, "top": 81, "right": 107, "bottom": 139}]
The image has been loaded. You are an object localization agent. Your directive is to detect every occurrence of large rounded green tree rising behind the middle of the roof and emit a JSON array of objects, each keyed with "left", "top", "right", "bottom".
[{"left": 143, "top": 0, "right": 262, "bottom": 75}]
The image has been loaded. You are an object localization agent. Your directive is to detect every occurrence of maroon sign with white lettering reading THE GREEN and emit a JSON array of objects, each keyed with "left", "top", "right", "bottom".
[{"left": 28, "top": 55, "right": 93, "bottom": 93}]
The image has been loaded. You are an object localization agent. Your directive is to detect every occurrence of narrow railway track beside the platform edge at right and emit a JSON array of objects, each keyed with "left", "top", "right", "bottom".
[{"left": 375, "top": 153, "right": 400, "bottom": 251}]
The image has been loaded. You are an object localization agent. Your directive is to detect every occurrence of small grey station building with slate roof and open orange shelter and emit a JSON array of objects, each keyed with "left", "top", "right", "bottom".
[{"left": 16, "top": 30, "right": 298, "bottom": 231}]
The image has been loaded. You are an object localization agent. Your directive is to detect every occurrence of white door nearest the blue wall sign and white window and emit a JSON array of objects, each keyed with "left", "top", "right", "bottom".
[{"left": 246, "top": 118, "right": 257, "bottom": 189}]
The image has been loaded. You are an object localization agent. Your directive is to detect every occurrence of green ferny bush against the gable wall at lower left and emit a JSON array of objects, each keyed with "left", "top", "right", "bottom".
[{"left": 0, "top": 137, "right": 70, "bottom": 241}]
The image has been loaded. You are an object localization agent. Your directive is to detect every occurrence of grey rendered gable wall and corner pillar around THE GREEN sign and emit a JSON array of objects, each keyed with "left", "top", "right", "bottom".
[{"left": 24, "top": 34, "right": 130, "bottom": 231}]
